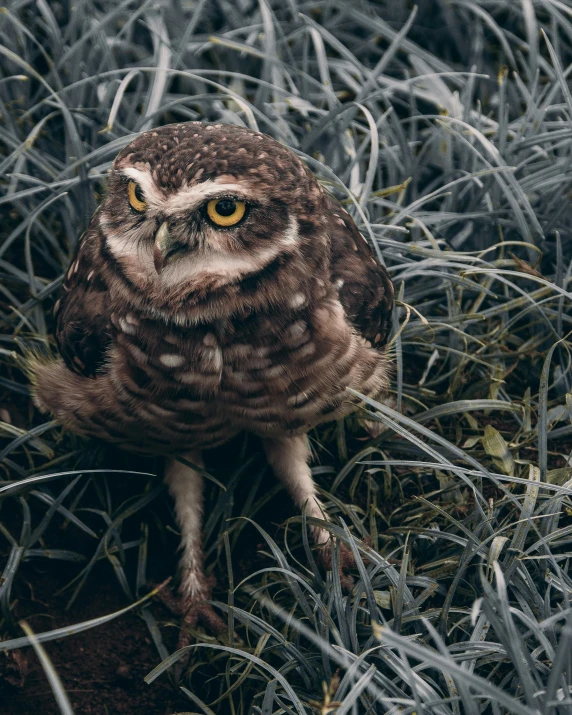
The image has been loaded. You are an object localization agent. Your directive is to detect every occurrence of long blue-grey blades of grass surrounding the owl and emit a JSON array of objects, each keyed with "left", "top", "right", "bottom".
[{"left": 0, "top": 0, "right": 572, "bottom": 715}]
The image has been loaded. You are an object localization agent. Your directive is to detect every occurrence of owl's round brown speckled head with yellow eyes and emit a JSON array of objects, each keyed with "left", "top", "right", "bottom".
[{"left": 97, "top": 122, "right": 328, "bottom": 304}]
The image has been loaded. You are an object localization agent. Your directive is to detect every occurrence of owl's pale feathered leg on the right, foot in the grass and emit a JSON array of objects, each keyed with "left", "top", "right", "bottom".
[{"left": 263, "top": 435, "right": 355, "bottom": 590}]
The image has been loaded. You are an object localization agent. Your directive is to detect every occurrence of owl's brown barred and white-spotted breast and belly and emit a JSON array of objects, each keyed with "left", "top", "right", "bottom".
[{"left": 94, "top": 296, "right": 387, "bottom": 453}]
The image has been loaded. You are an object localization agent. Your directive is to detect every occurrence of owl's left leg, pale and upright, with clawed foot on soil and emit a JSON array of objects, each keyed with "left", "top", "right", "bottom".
[{"left": 165, "top": 452, "right": 226, "bottom": 648}]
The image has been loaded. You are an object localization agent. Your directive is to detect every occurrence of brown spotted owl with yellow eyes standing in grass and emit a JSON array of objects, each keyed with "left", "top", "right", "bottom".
[{"left": 33, "top": 122, "right": 393, "bottom": 644}]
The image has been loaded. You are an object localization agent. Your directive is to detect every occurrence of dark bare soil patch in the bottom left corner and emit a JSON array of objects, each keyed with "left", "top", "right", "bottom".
[{"left": 0, "top": 567, "right": 191, "bottom": 715}]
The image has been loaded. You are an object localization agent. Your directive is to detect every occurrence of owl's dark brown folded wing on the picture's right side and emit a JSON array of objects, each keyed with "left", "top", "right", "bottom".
[{"left": 329, "top": 198, "right": 394, "bottom": 348}]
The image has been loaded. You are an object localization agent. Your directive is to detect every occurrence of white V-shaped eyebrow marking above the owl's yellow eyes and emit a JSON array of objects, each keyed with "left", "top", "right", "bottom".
[{"left": 120, "top": 166, "right": 248, "bottom": 214}]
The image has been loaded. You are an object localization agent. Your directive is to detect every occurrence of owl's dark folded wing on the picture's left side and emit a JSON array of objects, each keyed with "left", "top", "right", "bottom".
[{"left": 55, "top": 229, "right": 112, "bottom": 377}]
